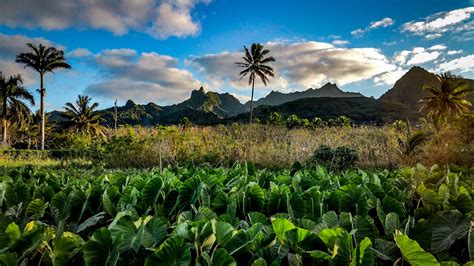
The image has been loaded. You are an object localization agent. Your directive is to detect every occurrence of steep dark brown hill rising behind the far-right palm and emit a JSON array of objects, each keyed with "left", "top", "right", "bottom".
[{"left": 380, "top": 66, "right": 474, "bottom": 111}]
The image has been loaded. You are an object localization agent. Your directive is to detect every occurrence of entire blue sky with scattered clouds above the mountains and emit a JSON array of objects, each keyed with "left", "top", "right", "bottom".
[{"left": 0, "top": 0, "right": 474, "bottom": 110}]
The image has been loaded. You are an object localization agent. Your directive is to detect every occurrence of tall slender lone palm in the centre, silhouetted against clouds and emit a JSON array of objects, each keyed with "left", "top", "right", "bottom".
[{"left": 235, "top": 43, "right": 275, "bottom": 123}]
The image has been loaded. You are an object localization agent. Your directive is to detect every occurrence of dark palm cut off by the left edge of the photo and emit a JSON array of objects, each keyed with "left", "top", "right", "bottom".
[{"left": 0, "top": 74, "right": 35, "bottom": 148}]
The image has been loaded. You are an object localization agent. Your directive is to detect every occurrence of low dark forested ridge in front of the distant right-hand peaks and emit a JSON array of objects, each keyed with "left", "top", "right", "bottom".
[{"left": 233, "top": 97, "right": 419, "bottom": 124}]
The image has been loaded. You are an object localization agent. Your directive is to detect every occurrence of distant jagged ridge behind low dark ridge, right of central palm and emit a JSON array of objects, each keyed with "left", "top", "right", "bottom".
[{"left": 245, "top": 82, "right": 363, "bottom": 108}]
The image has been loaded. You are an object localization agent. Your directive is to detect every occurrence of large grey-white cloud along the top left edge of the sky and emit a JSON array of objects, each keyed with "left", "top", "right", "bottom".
[{"left": 0, "top": 0, "right": 209, "bottom": 39}]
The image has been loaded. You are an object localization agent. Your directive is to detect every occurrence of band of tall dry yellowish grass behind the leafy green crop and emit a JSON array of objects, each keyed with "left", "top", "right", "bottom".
[{"left": 106, "top": 124, "right": 399, "bottom": 168}]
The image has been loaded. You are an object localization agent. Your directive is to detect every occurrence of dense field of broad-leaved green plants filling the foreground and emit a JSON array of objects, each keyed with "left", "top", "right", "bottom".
[{"left": 0, "top": 165, "right": 474, "bottom": 265}]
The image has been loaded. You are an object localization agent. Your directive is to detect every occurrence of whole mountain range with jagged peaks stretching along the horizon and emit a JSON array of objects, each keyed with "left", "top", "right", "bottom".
[{"left": 50, "top": 67, "right": 474, "bottom": 126}]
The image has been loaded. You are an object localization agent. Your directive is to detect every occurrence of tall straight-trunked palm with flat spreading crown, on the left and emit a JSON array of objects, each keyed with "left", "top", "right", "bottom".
[{"left": 16, "top": 43, "right": 71, "bottom": 150}]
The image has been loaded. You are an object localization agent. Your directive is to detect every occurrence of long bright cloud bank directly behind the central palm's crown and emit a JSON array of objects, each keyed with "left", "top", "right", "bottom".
[{"left": 186, "top": 42, "right": 396, "bottom": 90}]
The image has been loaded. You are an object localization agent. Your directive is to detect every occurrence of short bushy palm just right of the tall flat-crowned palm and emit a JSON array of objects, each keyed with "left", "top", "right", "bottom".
[{"left": 63, "top": 95, "right": 104, "bottom": 137}]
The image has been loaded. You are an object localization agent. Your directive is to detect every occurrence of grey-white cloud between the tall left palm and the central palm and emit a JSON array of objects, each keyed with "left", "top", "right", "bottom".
[{"left": 85, "top": 49, "right": 201, "bottom": 104}]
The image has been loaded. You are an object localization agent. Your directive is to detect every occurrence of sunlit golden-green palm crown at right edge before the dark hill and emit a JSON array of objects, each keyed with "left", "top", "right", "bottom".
[{"left": 420, "top": 73, "right": 472, "bottom": 118}]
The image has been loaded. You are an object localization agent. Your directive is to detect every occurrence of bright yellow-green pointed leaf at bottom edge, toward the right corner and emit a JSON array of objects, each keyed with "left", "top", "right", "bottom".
[{"left": 395, "top": 231, "right": 440, "bottom": 266}]
